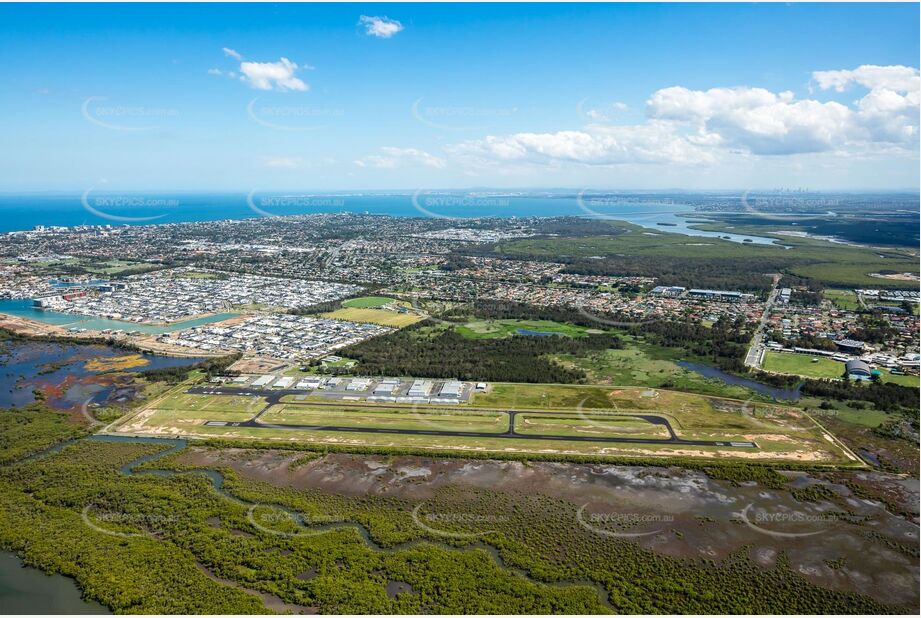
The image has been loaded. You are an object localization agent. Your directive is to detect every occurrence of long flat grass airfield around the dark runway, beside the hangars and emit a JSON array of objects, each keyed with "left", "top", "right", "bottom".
[{"left": 117, "top": 383, "right": 862, "bottom": 466}]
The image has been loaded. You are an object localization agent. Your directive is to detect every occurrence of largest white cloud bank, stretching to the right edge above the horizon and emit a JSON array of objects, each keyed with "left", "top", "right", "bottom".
[{"left": 447, "top": 65, "right": 919, "bottom": 167}]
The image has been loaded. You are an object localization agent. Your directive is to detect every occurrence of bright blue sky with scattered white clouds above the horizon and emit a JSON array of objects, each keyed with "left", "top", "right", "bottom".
[{"left": 0, "top": 3, "right": 921, "bottom": 192}]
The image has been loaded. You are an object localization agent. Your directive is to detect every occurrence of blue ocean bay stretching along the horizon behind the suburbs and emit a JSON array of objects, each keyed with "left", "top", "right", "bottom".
[{"left": 0, "top": 192, "right": 776, "bottom": 244}]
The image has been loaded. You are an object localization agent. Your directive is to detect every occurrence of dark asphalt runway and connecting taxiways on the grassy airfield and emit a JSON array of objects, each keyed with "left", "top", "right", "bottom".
[{"left": 192, "top": 386, "right": 758, "bottom": 448}]
